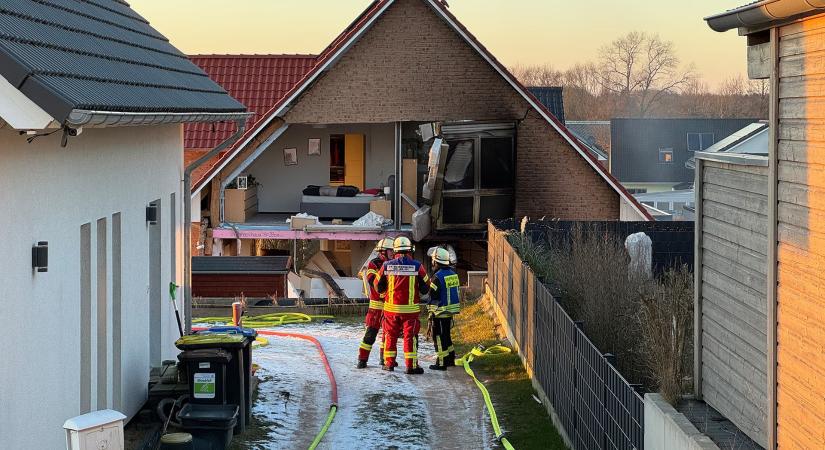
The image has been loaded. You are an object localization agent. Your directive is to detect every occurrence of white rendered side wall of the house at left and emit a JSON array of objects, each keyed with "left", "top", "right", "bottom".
[{"left": 0, "top": 126, "right": 183, "bottom": 450}]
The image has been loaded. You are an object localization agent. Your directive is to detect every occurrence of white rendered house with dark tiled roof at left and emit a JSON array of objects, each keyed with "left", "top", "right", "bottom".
[{"left": 0, "top": 0, "right": 245, "bottom": 450}]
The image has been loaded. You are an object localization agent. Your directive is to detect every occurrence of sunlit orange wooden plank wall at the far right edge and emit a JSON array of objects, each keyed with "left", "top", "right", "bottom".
[{"left": 772, "top": 15, "right": 825, "bottom": 448}]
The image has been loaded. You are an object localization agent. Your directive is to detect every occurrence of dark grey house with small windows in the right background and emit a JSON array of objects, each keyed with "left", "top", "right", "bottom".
[{"left": 610, "top": 119, "right": 756, "bottom": 194}]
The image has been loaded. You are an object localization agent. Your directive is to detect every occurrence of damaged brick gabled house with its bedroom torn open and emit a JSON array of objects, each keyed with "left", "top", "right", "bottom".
[{"left": 187, "top": 0, "right": 650, "bottom": 274}]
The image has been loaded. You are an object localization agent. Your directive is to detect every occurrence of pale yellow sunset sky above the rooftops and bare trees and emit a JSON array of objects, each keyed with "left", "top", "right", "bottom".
[{"left": 129, "top": 0, "right": 748, "bottom": 86}]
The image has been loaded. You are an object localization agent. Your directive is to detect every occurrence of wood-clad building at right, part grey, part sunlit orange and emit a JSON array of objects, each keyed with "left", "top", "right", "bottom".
[{"left": 697, "top": 0, "right": 825, "bottom": 449}]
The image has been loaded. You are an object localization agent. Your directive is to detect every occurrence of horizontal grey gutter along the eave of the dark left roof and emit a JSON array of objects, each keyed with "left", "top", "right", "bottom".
[{"left": 66, "top": 109, "right": 252, "bottom": 128}]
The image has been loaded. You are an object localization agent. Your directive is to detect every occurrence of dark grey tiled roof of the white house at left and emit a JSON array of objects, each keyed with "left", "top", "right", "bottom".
[{"left": 0, "top": 0, "right": 245, "bottom": 125}]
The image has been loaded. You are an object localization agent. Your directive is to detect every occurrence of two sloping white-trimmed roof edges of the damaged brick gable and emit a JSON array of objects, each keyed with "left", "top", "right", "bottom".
[{"left": 192, "top": 0, "right": 653, "bottom": 220}]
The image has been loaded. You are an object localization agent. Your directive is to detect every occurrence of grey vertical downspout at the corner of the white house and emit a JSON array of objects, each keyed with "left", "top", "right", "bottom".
[{"left": 183, "top": 119, "right": 248, "bottom": 334}]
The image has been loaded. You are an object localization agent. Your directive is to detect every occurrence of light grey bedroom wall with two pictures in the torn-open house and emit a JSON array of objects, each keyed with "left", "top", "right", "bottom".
[{"left": 247, "top": 124, "right": 395, "bottom": 212}]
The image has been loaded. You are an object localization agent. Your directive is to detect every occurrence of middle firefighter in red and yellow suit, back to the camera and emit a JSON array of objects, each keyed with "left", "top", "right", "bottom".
[{"left": 375, "top": 237, "right": 430, "bottom": 375}]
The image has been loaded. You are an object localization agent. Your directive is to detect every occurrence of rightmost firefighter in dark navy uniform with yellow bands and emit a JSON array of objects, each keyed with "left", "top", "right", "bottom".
[{"left": 427, "top": 247, "right": 461, "bottom": 370}]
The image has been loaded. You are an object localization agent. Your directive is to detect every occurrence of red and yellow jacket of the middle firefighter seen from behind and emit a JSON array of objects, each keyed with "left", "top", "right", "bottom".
[{"left": 375, "top": 255, "right": 430, "bottom": 314}]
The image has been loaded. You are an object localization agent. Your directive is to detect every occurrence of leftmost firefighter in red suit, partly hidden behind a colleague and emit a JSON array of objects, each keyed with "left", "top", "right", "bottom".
[{"left": 356, "top": 238, "right": 393, "bottom": 369}]
